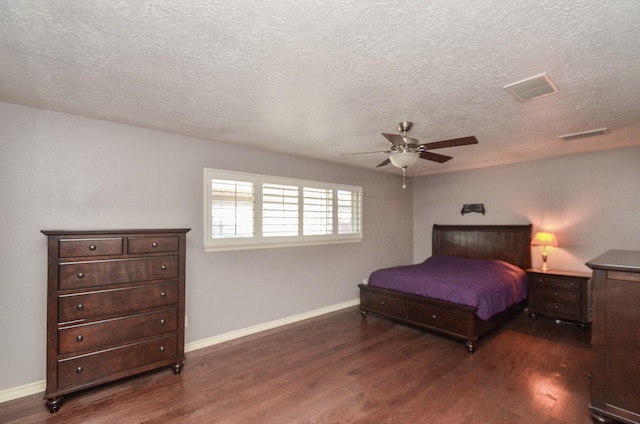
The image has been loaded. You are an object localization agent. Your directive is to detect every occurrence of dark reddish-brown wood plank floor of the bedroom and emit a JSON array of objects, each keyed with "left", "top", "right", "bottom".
[{"left": 0, "top": 308, "right": 591, "bottom": 424}]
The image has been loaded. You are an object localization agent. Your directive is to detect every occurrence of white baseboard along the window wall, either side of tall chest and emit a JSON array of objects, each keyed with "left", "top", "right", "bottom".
[{"left": 0, "top": 299, "right": 360, "bottom": 403}]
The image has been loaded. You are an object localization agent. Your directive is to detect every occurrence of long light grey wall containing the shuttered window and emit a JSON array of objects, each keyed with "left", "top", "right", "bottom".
[{"left": 0, "top": 103, "right": 413, "bottom": 391}]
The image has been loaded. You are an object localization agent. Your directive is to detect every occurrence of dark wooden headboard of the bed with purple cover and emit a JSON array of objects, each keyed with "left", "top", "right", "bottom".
[{"left": 432, "top": 224, "right": 532, "bottom": 269}]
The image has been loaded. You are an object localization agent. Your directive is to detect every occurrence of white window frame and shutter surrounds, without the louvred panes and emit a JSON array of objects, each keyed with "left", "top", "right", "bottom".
[{"left": 203, "top": 168, "right": 364, "bottom": 252}]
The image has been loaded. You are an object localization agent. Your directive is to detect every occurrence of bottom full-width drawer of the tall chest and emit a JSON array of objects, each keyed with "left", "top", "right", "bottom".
[{"left": 58, "top": 335, "right": 177, "bottom": 390}]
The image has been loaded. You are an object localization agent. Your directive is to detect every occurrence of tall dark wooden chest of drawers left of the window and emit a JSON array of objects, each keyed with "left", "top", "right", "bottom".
[{"left": 42, "top": 229, "right": 189, "bottom": 412}]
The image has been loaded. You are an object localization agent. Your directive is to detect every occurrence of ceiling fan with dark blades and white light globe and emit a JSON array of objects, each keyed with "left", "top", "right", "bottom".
[{"left": 345, "top": 121, "right": 478, "bottom": 188}]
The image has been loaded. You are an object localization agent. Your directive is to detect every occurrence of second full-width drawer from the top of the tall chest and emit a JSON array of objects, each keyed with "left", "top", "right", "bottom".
[{"left": 58, "top": 282, "right": 178, "bottom": 322}]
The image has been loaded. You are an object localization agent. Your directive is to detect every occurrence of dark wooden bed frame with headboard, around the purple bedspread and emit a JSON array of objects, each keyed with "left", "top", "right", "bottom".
[{"left": 358, "top": 224, "right": 532, "bottom": 353}]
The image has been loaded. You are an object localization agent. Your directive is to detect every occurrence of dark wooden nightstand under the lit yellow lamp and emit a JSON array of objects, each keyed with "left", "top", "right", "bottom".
[{"left": 527, "top": 268, "right": 591, "bottom": 329}]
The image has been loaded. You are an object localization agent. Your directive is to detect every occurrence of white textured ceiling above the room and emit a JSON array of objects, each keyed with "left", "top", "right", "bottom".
[{"left": 0, "top": 0, "right": 640, "bottom": 176}]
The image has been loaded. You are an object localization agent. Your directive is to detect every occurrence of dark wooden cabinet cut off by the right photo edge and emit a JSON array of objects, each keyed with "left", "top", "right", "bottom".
[{"left": 587, "top": 250, "right": 640, "bottom": 424}]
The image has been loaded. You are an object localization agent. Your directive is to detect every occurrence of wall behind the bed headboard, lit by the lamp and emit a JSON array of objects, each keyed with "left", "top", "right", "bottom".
[{"left": 413, "top": 146, "right": 640, "bottom": 271}]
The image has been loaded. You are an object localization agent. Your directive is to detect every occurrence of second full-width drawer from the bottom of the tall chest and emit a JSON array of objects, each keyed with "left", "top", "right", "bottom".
[{"left": 58, "top": 308, "right": 178, "bottom": 355}]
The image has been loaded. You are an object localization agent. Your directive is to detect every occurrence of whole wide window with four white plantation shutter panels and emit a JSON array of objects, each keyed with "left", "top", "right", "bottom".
[{"left": 204, "top": 169, "right": 362, "bottom": 251}]
